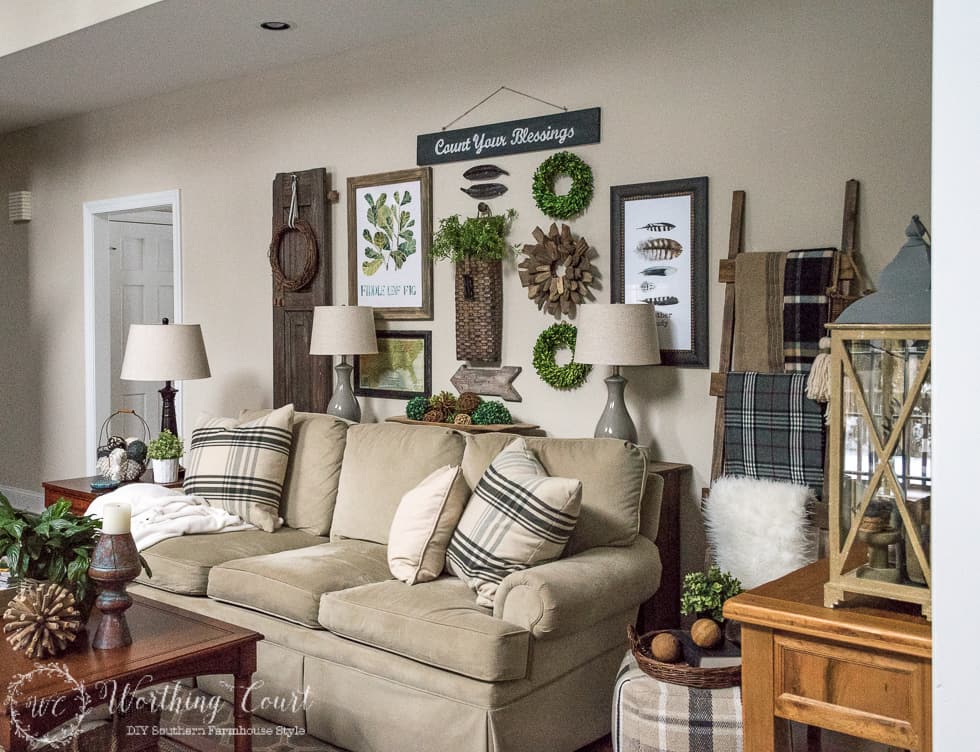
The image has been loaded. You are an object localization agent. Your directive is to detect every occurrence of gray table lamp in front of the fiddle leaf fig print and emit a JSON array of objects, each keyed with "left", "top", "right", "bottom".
[{"left": 310, "top": 306, "right": 378, "bottom": 423}]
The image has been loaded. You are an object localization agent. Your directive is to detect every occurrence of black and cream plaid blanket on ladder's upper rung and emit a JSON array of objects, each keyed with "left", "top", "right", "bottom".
[{"left": 783, "top": 248, "right": 837, "bottom": 372}]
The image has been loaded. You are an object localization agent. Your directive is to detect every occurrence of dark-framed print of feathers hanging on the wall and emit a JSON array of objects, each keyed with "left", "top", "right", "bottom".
[{"left": 609, "top": 177, "right": 708, "bottom": 368}]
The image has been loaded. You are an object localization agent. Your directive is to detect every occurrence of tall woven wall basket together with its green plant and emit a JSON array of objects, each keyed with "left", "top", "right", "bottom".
[{"left": 429, "top": 203, "right": 517, "bottom": 362}]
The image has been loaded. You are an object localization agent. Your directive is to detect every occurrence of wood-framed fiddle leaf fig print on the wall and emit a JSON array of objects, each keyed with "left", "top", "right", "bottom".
[{"left": 347, "top": 167, "right": 432, "bottom": 321}]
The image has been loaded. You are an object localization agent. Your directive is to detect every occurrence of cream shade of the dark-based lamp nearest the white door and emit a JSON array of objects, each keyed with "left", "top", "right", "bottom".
[{"left": 119, "top": 324, "right": 211, "bottom": 381}]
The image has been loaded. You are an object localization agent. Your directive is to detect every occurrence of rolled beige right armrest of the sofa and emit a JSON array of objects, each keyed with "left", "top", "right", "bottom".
[{"left": 493, "top": 535, "right": 662, "bottom": 639}]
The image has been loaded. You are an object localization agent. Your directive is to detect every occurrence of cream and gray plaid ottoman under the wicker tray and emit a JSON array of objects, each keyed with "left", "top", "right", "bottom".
[{"left": 612, "top": 653, "right": 742, "bottom": 752}]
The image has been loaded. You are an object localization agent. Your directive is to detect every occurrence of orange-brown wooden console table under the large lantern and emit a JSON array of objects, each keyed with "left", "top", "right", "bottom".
[{"left": 725, "top": 559, "right": 932, "bottom": 752}]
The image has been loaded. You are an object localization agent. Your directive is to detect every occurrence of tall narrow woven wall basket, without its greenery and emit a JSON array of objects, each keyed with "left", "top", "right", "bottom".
[{"left": 456, "top": 259, "right": 504, "bottom": 363}]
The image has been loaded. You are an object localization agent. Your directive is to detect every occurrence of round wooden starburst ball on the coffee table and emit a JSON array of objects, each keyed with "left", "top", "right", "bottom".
[{"left": 3, "top": 582, "right": 82, "bottom": 658}]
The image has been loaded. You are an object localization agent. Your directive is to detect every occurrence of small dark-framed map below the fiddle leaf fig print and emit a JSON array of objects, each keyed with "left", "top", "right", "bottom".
[{"left": 354, "top": 331, "right": 432, "bottom": 400}]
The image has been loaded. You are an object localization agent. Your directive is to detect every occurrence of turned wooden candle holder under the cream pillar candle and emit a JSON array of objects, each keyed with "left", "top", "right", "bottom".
[{"left": 88, "top": 533, "right": 142, "bottom": 650}]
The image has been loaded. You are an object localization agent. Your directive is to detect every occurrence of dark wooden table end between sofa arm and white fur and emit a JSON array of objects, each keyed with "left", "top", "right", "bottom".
[{"left": 636, "top": 462, "right": 691, "bottom": 634}]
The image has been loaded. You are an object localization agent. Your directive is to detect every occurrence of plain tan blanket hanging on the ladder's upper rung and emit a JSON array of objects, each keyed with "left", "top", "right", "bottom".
[{"left": 732, "top": 251, "right": 786, "bottom": 373}]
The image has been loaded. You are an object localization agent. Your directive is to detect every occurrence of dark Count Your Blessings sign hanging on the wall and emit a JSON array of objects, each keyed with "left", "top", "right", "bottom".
[{"left": 416, "top": 107, "right": 599, "bottom": 165}]
